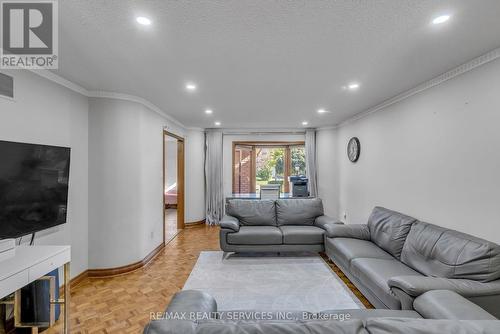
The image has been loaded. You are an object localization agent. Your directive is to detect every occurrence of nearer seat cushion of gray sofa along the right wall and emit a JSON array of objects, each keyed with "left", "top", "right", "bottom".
[{"left": 351, "top": 258, "right": 422, "bottom": 310}]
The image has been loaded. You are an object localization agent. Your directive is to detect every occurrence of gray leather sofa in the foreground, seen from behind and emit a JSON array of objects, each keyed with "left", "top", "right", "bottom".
[{"left": 144, "top": 290, "right": 500, "bottom": 334}]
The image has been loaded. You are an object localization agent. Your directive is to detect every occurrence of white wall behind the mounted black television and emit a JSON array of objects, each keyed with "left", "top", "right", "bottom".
[{"left": 0, "top": 70, "right": 88, "bottom": 277}]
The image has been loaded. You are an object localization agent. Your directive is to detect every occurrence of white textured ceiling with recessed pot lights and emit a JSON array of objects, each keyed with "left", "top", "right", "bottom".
[{"left": 56, "top": 0, "right": 500, "bottom": 128}]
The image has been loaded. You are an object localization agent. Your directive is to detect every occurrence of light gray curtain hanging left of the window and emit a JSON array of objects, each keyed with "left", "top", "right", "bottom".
[{"left": 205, "top": 130, "right": 224, "bottom": 225}]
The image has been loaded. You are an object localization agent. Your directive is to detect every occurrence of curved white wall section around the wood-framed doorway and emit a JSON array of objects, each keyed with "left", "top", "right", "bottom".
[{"left": 89, "top": 98, "right": 204, "bottom": 269}]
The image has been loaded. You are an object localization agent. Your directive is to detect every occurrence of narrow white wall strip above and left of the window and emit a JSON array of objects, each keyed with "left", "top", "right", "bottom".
[{"left": 222, "top": 133, "right": 305, "bottom": 197}]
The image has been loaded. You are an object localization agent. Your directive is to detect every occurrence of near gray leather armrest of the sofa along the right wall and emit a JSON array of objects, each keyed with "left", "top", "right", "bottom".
[{"left": 388, "top": 276, "right": 500, "bottom": 301}]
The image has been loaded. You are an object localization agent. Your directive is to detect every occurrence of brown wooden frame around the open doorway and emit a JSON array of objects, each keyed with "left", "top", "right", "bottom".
[{"left": 162, "top": 130, "right": 185, "bottom": 243}]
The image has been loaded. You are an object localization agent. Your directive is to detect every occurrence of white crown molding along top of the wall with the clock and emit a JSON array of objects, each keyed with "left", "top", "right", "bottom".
[{"left": 332, "top": 48, "right": 500, "bottom": 130}]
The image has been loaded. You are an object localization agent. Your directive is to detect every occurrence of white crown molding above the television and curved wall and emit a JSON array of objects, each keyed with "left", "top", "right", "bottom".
[{"left": 28, "top": 70, "right": 188, "bottom": 130}]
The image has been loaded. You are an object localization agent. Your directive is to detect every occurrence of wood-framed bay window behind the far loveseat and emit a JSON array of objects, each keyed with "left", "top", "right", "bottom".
[{"left": 233, "top": 142, "right": 306, "bottom": 194}]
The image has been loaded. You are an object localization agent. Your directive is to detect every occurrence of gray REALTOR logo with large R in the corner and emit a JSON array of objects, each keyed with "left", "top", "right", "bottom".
[{"left": 0, "top": 0, "right": 58, "bottom": 69}]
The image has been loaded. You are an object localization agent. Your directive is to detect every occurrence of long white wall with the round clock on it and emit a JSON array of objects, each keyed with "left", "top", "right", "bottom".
[{"left": 320, "top": 60, "right": 500, "bottom": 242}]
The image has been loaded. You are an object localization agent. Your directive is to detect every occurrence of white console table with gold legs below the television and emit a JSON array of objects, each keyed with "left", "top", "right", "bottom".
[{"left": 0, "top": 246, "right": 71, "bottom": 334}]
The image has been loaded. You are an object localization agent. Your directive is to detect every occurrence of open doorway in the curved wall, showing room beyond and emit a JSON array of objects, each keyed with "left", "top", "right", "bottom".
[{"left": 163, "top": 131, "right": 184, "bottom": 243}]
